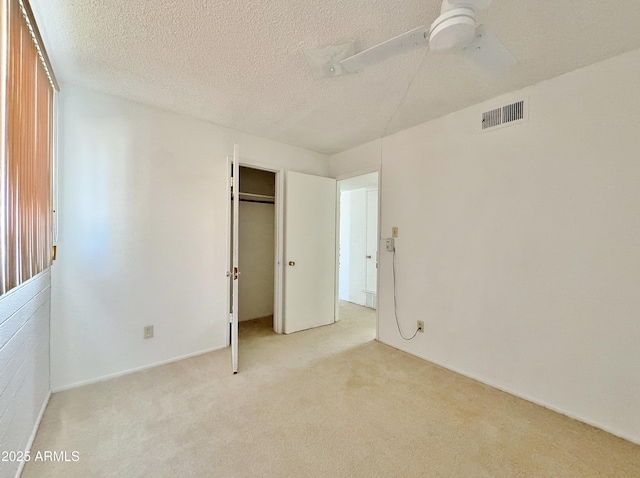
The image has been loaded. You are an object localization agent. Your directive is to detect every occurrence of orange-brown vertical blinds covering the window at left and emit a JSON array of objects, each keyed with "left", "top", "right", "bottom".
[{"left": 0, "top": 0, "right": 54, "bottom": 294}]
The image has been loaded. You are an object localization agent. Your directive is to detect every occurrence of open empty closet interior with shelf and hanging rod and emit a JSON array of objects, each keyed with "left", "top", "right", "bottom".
[{"left": 238, "top": 166, "right": 276, "bottom": 327}]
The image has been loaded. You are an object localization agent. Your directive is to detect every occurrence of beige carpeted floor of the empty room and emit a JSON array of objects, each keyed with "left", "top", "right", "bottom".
[{"left": 23, "top": 303, "right": 640, "bottom": 478}]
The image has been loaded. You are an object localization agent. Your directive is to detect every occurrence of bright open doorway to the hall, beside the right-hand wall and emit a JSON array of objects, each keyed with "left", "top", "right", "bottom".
[{"left": 338, "top": 171, "right": 379, "bottom": 320}]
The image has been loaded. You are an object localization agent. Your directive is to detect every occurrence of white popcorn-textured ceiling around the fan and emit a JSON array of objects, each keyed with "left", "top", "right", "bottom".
[{"left": 31, "top": 0, "right": 640, "bottom": 153}]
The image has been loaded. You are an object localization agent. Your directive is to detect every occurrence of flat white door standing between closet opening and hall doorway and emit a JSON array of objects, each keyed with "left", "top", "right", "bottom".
[{"left": 284, "top": 171, "right": 336, "bottom": 334}]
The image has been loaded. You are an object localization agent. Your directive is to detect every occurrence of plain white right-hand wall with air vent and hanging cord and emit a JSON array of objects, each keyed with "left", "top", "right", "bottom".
[{"left": 331, "top": 51, "right": 640, "bottom": 442}]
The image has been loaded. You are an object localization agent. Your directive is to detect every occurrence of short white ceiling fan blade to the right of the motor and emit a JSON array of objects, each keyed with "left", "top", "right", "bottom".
[{"left": 459, "top": 25, "right": 518, "bottom": 77}]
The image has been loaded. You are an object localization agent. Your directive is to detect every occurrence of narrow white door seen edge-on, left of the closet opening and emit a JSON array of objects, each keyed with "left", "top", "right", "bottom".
[{"left": 231, "top": 143, "right": 240, "bottom": 373}]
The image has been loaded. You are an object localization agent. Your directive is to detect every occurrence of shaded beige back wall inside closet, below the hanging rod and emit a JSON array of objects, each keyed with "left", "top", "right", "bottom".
[{"left": 238, "top": 202, "right": 275, "bottom": 321}]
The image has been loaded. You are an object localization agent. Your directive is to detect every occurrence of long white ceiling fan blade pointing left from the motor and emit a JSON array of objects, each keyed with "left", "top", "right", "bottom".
[{"left": 340, "top": 26, "right": 429, "bottom": 73}]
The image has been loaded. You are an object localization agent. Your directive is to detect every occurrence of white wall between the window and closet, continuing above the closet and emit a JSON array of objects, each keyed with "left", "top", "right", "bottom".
[{"left": 51, "top": 85, "right": 328, "bottom": 390}]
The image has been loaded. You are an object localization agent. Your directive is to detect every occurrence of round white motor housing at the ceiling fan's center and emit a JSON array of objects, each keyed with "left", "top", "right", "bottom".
[{"left": 429, "top": 7, "right": 476, "bottom": 52}]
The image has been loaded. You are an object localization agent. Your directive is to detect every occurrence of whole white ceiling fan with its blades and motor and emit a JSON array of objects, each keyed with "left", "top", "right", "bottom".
[{"left": 306, "top": 0, "right": 517, "bottom": 79}]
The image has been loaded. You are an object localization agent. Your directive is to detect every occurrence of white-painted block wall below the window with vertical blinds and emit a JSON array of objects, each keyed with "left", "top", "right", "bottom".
[{"left": 0, "top": 270, "right": 51, "bottom": 476}]
